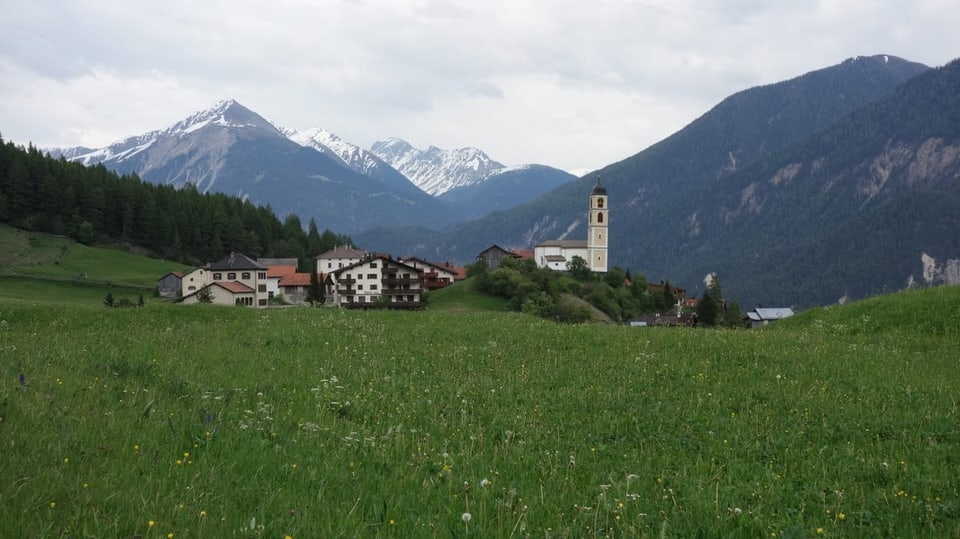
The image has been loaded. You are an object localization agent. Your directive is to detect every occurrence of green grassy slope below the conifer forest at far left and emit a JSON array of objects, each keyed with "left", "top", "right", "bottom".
[{"left": 0, "top": 221, "right": 186, "bottom": 301}]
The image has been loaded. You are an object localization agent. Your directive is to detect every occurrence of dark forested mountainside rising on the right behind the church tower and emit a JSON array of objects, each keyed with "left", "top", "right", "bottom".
[{"left": 357, "top": 55, "right": 960, "bottom": 308}]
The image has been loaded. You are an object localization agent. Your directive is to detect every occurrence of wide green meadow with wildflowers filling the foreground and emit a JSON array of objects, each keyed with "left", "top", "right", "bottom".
[{"left": 0, "top": 285, "right": 960, "bottom": 538}]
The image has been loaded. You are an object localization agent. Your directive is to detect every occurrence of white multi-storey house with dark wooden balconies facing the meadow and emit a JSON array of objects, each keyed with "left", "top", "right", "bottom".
[{"left": 324, "top": 255, "right": 423, "bottom": 309}]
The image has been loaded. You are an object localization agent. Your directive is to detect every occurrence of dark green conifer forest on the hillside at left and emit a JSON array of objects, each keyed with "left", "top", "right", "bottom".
[{"left": 0, "top": 137, "right": 352, "bottom": 269}]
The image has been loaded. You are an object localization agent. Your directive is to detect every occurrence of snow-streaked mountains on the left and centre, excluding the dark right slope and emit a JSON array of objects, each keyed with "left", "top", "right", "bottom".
[{"left": 46, "top": 103, "right": 574, "bottom": 233}]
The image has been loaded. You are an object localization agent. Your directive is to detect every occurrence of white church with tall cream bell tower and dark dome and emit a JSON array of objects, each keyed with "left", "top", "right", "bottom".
[{"left": 533, "top": 178, "right": 610, "bottom": 273}]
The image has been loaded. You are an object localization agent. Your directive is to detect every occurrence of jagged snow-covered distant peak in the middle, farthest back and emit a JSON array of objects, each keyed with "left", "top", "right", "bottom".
[{"left": 370, "top": 138, "right": 505, "bottom": 196}]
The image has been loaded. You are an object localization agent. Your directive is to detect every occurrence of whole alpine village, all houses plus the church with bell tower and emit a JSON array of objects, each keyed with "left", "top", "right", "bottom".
[{"left": 157, "top": 178, "right": 793, "bottom": 327}]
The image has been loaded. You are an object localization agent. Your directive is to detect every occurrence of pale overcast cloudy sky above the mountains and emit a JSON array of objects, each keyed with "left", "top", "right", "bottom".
[{"left": 0, "top": 0, "right": 960, "bottom": 172}]
